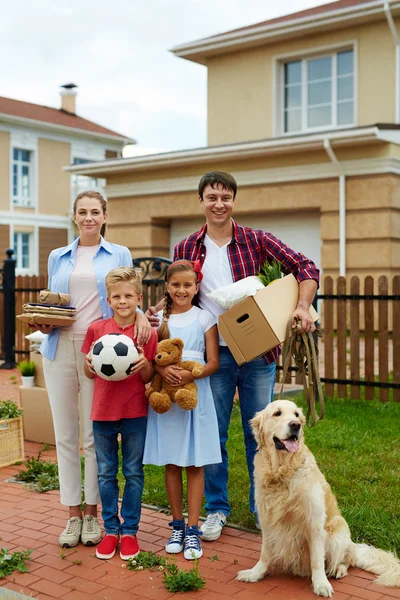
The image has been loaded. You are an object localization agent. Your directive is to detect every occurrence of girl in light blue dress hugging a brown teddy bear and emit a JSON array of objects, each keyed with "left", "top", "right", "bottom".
[{"left": 143, "top": 260, "right": 221, "bottom": 560}]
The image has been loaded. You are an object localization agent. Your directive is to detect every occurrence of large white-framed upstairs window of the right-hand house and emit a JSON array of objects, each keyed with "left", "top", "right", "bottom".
[{"left": 283, "top": 50, "right": 354, "bottom": 133}]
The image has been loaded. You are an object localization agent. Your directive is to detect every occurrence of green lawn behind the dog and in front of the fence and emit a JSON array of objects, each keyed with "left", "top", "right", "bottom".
[{"left": 126, "top": 396, "right": 400, "bottom": 555}]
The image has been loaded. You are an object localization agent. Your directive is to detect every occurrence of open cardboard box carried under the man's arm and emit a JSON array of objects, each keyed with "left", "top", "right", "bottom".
[{"left": 218, "top": 275, "right": 319, "bottom": 365}]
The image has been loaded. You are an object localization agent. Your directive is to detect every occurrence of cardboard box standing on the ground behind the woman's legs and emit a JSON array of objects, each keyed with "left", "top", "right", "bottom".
[{"left": 19, "top": 386, "right": 83, "bottom": 448}]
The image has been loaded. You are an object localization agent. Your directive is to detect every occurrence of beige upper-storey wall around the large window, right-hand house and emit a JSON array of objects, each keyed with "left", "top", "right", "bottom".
[{"left": 207, "top": 20, "right": 400, "bottom": 145}]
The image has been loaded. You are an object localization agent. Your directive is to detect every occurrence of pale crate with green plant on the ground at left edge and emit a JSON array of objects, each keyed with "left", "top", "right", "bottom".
[{"left": 0, "top": 399, "right": 24, "bottom": 468}]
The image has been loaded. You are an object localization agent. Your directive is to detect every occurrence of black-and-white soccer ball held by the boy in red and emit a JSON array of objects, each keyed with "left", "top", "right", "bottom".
[{"left": 91, "top": 333, "right": 139, "bottom": 381}]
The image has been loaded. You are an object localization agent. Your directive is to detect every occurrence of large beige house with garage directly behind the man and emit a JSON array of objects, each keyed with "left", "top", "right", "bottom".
[{"left": 70, "top": 0, "right": 400, "bottom": 277}]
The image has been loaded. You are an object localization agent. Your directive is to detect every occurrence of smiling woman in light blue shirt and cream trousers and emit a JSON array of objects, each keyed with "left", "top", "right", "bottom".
[{"left": 40, "top": 191, "right": 151, "bottom": 548}]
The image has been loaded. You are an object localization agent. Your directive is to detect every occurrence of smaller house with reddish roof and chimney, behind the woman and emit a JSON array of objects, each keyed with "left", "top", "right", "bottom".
[{"left": 0, "top": 84, "right": 134, "bottom": 275}]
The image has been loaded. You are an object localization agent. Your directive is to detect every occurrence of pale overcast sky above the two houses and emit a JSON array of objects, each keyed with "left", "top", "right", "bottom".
[{"left": 0, "top": 0, "right": 332, "bottom": 152}]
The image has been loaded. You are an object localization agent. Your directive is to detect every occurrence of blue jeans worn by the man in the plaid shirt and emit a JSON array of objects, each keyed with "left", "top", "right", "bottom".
[{"left": 204, "top": 346, "right": 276, "bottom": 516}]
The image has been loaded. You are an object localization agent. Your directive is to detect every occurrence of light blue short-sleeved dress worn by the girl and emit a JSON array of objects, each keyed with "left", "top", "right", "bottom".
[{"left": 143, "top": 306, "right": 221, "bottom": 467}]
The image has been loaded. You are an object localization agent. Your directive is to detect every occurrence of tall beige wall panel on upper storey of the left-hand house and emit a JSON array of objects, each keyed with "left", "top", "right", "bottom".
[{"left": 38, "top": 139, "right": 71, "bottom": 216}]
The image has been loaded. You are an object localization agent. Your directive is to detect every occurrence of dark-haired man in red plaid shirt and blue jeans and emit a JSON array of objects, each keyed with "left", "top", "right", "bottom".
[{"left": 146, "top": 171, "right": 319, "bottom": 541}]
